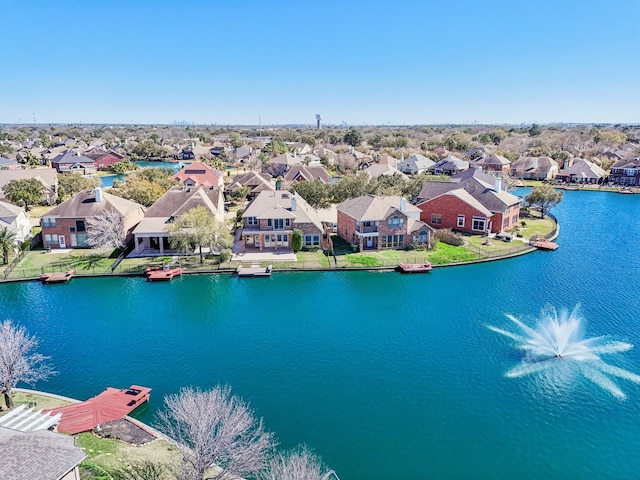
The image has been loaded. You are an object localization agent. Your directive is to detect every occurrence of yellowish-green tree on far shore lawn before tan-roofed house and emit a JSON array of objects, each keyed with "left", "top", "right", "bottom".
[{"left": 168, "top": 206, "right": 233, "bottom": 265}]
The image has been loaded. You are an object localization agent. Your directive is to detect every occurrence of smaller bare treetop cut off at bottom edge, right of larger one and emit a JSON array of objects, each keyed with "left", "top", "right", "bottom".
[{"left": 258, "top": 445, "right": 337, "bottom": 480}]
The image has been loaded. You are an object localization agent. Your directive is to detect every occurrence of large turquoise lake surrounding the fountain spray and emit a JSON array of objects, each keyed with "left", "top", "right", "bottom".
[{"left": 0, "top": 192, "right": 640, "bottom": 480}]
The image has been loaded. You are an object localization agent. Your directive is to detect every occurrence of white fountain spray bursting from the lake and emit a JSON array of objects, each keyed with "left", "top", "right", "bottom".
[{"left": 487, "top": 306, "right": 640, "bottom": 400}]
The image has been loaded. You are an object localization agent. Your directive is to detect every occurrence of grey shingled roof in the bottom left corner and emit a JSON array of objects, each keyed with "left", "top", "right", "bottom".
[{"left": 0, "top": 427, "right": 87, "bottom": 480}]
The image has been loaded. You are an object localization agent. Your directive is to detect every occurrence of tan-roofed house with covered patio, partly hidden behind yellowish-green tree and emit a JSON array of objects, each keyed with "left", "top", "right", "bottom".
[{"left": 133, "top": 185, "right": 224, "bottom": 256}]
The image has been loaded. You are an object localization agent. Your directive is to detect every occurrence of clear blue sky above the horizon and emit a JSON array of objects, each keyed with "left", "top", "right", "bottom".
[{"left": 0, "top": 0, "right": 640, "bottom": 125}]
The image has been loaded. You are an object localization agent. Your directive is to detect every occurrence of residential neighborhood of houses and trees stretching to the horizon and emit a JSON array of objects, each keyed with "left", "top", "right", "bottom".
[{"left": 0, "top": 122, "right": 640, "bottom": 270}]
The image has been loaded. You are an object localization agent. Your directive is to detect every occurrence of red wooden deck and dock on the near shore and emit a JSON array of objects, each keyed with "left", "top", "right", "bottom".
[{"left": 45, "top": 385, "right": 151, "bottom": 435}]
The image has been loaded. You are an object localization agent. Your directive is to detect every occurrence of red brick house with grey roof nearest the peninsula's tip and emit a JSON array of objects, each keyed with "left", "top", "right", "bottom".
[{"left": 416, "top": 169, "right": 522, "bottom": 233}]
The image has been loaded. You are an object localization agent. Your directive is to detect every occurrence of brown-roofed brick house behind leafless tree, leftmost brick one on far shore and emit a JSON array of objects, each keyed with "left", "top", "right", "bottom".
[{"left": 40, "top": 187, "right": 144, "bottom": 249}]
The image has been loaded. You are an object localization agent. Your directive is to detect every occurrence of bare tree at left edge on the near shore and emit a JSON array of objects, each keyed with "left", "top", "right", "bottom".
[{"left": 0, "top": 320, "right": 55, "bottom": 409}]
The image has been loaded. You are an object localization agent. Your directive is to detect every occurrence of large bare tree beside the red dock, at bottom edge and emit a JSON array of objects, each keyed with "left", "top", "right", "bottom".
[{"left": 158, "top": 386, "right": 275, "bottom": 480}]
